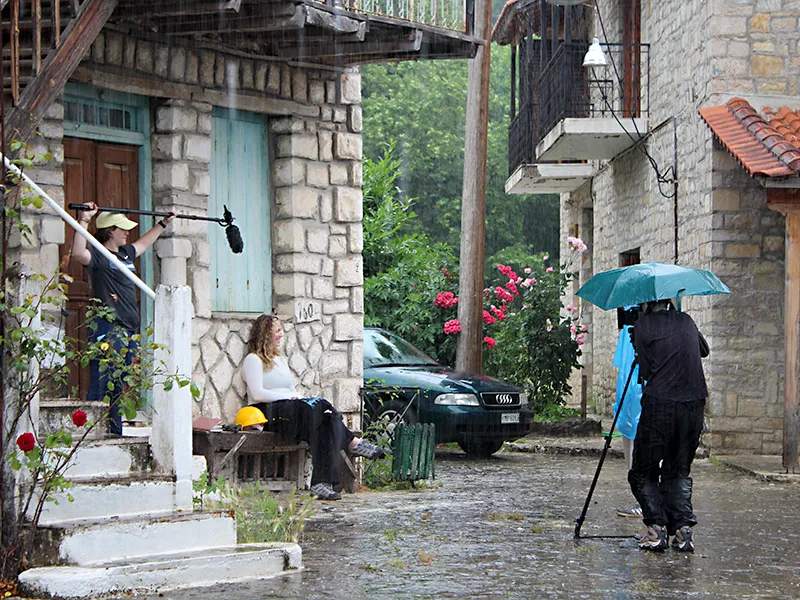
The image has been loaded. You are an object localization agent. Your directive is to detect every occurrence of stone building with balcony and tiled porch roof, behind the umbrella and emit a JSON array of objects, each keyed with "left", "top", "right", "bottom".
[{"left": 494, "top": 0, "right": 800, "bottom": 466}]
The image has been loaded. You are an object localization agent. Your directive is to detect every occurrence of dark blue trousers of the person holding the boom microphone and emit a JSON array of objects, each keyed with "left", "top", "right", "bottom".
[{"left": 86, "top": 319, "right": 138, "bottom": 435}]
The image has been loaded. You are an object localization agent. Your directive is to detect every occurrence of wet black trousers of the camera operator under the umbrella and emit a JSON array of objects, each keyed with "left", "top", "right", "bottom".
[{"left": 628, "top": 394, "right": 705, "bottom": 535}]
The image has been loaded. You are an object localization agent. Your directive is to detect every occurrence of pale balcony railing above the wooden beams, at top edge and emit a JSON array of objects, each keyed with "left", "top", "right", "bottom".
[{"left": 342, "top": 0, "right": 474, "bottom": 34}]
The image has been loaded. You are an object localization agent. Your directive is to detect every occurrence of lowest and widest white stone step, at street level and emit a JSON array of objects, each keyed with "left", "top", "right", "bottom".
[{"left": 19, "top": 543, "right": 302, "bottom": 598}]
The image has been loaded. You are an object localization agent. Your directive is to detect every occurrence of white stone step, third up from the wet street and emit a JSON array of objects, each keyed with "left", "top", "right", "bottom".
[{"left": 39, "top": 473, "right": 175, "bottom": 525}]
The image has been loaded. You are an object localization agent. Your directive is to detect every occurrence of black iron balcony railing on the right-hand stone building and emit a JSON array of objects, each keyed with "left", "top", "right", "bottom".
[{"left": 508, "top": 41, "right": 650, "bottom": 174}]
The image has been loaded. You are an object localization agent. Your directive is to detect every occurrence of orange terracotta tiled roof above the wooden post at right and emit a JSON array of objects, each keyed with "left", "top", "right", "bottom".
[{"left": 700, "top": 98, "right": 800, "bottom": 177}]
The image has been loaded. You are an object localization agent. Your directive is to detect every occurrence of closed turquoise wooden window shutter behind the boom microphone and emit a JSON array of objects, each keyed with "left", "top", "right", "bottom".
[{"left": 208, "top": 108, "right": 272, "bottom": 313}]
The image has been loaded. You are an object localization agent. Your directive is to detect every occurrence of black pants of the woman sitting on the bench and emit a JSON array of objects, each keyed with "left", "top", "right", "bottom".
[{"left": 252, "top": 398, "right": 354, "bottom": 486}]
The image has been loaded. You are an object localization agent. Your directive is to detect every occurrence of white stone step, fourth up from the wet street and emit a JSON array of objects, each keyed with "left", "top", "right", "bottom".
[{"left": 64, "top": 438, "right": 150, "bottom": 479}]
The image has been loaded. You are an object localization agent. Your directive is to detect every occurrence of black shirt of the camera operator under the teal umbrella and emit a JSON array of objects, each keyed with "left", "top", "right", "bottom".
[{"left": 634, "top": 310, "right": 708, "bottom": 402}]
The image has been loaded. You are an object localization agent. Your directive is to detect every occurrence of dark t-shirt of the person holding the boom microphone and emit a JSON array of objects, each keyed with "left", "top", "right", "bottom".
[{"left": 86, "top": 244, "right": 140, "bottom": 331}]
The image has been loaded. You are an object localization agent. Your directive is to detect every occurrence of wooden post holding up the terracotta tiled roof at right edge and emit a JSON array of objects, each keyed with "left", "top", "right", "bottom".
[{"left": 767, "top": 189, "right": 800, "bottom": 473}]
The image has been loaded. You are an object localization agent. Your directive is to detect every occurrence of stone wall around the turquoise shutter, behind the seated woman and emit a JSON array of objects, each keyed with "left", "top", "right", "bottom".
[{"left": 22, "top": 29, "right": 363, "bottom": 429}]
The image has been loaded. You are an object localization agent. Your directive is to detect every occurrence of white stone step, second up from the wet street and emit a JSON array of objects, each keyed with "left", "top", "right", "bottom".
[{"left": 34, "top": 513, "right": 236, "bottom": 566}]
